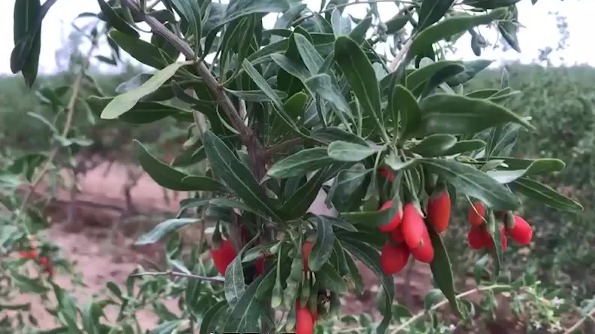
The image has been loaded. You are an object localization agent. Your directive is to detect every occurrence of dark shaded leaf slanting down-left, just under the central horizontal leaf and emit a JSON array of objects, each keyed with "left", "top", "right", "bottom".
[{"left": 281, "top": 169, "right": 327, "bottom": 220}]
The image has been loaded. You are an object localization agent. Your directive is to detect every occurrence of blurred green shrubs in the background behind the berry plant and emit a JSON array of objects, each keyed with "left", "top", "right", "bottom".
[{"left": 0, "top": 65, "right": 595, "bottom": 298}]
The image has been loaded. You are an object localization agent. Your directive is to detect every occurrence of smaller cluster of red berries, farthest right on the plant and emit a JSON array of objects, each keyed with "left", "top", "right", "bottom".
[{"left": 467, "top": 202, "right": 533, "bottom": 251}]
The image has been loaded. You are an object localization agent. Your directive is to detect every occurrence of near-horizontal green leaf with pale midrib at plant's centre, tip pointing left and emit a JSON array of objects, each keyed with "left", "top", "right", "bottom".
[{"left": 267, "top": 147, "right": 333, "bottom": 178}]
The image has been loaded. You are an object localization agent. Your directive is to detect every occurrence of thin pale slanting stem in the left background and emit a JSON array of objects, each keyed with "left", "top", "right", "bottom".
[{"left": 16, "top": 40, "right": 97, "bottom": 222}]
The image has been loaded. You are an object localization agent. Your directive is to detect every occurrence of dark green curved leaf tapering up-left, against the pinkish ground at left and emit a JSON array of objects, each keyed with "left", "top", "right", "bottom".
[{"left": 134, "top": 140, "right": 194, "bottom": 191}]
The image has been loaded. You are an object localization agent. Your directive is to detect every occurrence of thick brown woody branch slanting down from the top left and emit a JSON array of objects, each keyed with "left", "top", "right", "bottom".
[{"left": 121, "top": 0, "right": 253, "bottom": 144}]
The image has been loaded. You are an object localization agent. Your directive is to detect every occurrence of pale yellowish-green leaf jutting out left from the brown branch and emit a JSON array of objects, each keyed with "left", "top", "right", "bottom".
[{"left": 101, "top": 63, "right": 184, "bottom": 119}]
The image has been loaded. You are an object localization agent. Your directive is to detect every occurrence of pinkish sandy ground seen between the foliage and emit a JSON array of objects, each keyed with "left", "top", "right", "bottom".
[{"left": 7, "top": 164, "right": 431, "bottom": 329}]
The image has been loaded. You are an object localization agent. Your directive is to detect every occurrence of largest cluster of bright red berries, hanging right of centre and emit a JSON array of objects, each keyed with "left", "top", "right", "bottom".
[{"left": 379, "top": 168, "right": 451, "bottom": 275}]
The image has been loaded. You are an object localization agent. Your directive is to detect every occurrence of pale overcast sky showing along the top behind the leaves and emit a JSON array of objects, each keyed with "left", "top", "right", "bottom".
[{"left": 0, "top": 0, "right": 595, "bottom": 74}]
